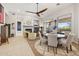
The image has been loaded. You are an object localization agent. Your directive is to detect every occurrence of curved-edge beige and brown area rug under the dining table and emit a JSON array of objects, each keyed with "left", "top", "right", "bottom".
[{"left": 34, "top": 40, "right": 79, "bottom": 56}]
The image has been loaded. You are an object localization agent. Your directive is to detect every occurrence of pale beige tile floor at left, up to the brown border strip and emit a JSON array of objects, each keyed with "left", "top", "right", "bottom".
[{"left": 0, "top": 37, "right": 34, "bottom": 56}]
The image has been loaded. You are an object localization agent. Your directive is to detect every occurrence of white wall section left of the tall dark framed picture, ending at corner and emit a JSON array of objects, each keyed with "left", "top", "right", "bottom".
[{"left": 5, "top": 13, "right": 16, "bottom": 36}]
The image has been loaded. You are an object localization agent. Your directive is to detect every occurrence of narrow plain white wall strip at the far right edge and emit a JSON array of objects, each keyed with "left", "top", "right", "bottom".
[{"left": 73, "top": 4, "right": 79, "bottom": 41}]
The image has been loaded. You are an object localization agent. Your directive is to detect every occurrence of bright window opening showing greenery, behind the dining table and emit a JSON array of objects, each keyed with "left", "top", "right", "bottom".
[{"left": 58, "top": 22, "right": 71, "bottom": 31}]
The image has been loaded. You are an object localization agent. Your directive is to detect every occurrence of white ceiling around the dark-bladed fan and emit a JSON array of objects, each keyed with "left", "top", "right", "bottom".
[{"left": 2, "top": 3, "right": 71, "bottom": 17}]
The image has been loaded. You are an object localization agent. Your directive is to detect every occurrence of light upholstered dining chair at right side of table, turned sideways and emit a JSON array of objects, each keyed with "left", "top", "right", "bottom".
[{"left": 59, "top": 33, "right": 74, "bottom": 53}]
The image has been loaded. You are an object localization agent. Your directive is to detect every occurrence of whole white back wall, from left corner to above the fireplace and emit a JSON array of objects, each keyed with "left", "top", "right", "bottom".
[{"left": 6, "top": 13, "right": 38, "bottom": 36}]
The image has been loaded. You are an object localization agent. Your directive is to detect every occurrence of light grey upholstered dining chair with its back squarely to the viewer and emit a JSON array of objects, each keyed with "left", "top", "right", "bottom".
[{"left": 48, "top": 33, "right": 58, "bottom": 54}]
